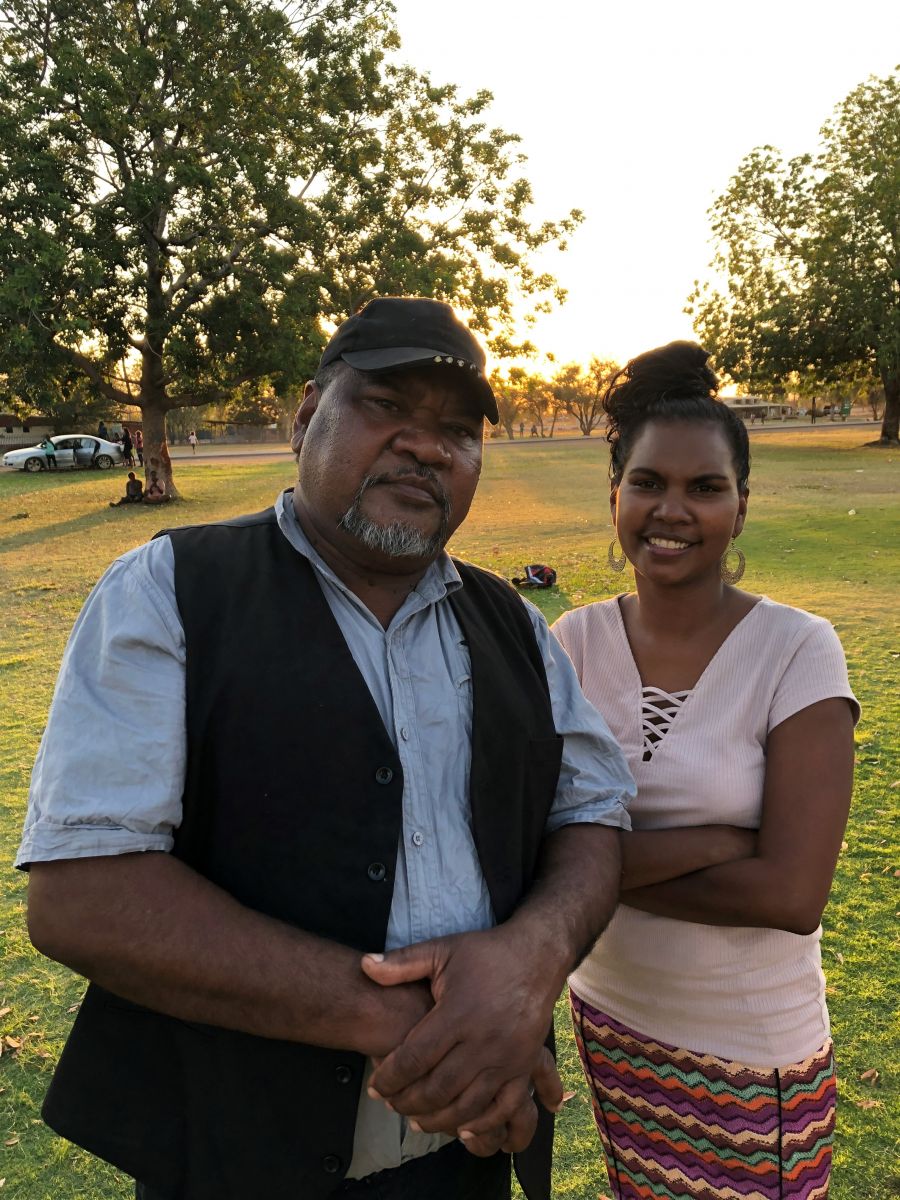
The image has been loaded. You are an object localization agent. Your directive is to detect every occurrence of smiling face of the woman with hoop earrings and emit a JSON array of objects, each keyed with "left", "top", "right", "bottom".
[{"left": 610, "top": 420, "right": 746, "bottom": 584}]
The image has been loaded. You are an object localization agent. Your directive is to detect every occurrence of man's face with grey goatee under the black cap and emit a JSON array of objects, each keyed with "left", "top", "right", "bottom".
[{"left": 292, "top": 364, "right": 484, "bottom": 569}]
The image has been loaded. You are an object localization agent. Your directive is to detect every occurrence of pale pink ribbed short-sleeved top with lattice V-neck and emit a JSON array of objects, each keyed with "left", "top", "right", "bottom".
[{"left": 553, "top": 596, "right": 859, "bottom": 1067}]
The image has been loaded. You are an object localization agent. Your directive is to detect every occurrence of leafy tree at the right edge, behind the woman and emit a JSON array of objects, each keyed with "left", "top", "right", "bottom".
[{"left": 688, "top": 73, "right": 900, "bottom": 445}]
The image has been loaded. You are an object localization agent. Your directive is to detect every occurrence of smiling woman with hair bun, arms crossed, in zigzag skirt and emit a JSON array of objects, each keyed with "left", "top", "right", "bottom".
[{"left": 556, "top": 342, "right": 859, "bottom": 1200}]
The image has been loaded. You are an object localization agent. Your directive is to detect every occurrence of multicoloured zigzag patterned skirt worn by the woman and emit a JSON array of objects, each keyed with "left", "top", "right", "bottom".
[{"left": 571, "top": 992, "right": 835, "bottom": 1200}]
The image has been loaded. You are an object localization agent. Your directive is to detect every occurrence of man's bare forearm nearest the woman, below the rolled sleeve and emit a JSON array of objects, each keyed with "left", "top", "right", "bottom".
[{"left": 500, "top": 823, "right": 622, "bottom": 995}]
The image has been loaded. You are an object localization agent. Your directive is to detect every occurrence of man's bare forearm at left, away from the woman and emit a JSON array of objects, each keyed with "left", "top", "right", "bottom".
[{"left": 29, "top": 853, "right": 430, "bottom": 1055}]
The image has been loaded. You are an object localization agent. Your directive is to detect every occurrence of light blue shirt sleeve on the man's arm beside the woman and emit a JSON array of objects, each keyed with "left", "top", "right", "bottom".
[{"left": 526, "top": 601, "right": 635, "bottom": 833}]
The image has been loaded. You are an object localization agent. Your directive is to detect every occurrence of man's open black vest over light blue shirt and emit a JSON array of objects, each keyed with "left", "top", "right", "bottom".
[{"left": 43, "top": 509, "right": 562, "bottom": 1200}]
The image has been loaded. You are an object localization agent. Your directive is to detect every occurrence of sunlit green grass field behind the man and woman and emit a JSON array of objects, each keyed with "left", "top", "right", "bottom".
[{"left": 0, "top": 428, "right": 900, "bottom": 1200}]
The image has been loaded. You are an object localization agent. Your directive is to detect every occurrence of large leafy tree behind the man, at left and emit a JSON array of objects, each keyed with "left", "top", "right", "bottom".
[{"left": 0, "top": 0, "right": 581, "bottom": 494}]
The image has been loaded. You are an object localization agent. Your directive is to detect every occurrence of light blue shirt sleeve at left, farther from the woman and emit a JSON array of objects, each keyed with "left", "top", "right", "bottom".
[{"left": 16, "top": 538, "right": 186, "bottom": 868}]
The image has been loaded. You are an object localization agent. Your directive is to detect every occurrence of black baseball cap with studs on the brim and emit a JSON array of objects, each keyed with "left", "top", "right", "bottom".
[{"left": 319, "top": 296, "right": 499, "bottom": 425}]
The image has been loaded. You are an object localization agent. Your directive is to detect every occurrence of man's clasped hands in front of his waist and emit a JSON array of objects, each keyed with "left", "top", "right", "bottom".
[{"left": 361, "top": 923, "right": 564, "bottom": 1156}]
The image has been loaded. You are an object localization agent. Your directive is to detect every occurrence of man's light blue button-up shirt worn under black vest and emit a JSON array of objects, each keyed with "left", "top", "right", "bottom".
[{"left": 16, "top": 492, "right": 634, "bottom": 1176}]
